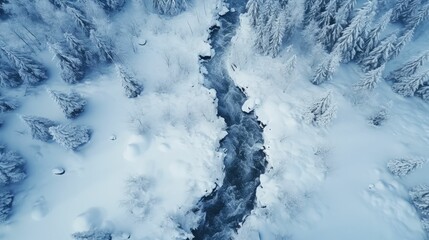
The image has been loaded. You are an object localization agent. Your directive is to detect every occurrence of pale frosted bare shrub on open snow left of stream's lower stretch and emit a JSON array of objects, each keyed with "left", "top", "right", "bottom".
[{"left": 123, "top": 176, "right": 155, "bottom": 220}]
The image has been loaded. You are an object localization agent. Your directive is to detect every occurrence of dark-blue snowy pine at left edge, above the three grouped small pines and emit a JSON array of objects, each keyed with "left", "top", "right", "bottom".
[{"left": 0, "top": 46, "right": 48, "bottom": 86}]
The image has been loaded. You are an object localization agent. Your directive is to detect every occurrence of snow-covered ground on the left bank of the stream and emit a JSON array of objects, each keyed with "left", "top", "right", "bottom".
[{"left": 0, "top": 1, "right": 225, "bottom": 240}]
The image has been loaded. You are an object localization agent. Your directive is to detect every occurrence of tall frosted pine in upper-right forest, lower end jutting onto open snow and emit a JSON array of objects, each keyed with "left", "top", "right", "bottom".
[{"left": 334, "top": 0, "right": 376, "bottom": 62}]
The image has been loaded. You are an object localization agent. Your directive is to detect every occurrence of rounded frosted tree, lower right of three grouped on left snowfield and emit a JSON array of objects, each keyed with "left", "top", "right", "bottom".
[{"left": 49, "top": 124, "right": 92, "bottom": 150}]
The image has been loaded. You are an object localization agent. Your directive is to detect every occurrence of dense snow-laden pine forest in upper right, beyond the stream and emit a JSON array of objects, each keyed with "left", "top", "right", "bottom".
[{"left": 247, "top": 0, "right": 429, "bottom": 100}]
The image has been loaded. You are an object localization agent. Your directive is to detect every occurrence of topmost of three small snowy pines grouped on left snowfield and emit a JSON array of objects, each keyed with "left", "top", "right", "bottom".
[{"left": 49, "top": 90, "right": 87, "bottom": 119}]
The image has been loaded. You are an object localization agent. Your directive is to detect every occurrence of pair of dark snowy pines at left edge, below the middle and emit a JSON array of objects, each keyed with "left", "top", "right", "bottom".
[{"left": 0, "top": 145, "right": 26, "bottom": 223}]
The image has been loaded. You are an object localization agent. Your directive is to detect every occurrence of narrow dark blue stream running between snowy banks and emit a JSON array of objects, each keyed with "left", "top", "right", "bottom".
[{"left": 192, "top": 0, "right": 266, "bottom": 240}]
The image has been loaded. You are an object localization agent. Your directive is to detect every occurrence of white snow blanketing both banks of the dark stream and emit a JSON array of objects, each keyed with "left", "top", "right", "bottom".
[{"left": 0, "top": 0, "right": 429, "bottom": 240}]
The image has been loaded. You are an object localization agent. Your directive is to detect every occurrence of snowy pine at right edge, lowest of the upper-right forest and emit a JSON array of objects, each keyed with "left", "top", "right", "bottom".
[{"left": 392, "top": 71, "right": 429, "bottom": 97}]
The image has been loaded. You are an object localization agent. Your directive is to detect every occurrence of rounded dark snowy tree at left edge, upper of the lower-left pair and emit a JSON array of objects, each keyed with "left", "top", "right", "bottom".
[{"left": 0, "top": 151, "right": 26, "bottom": 186}]
